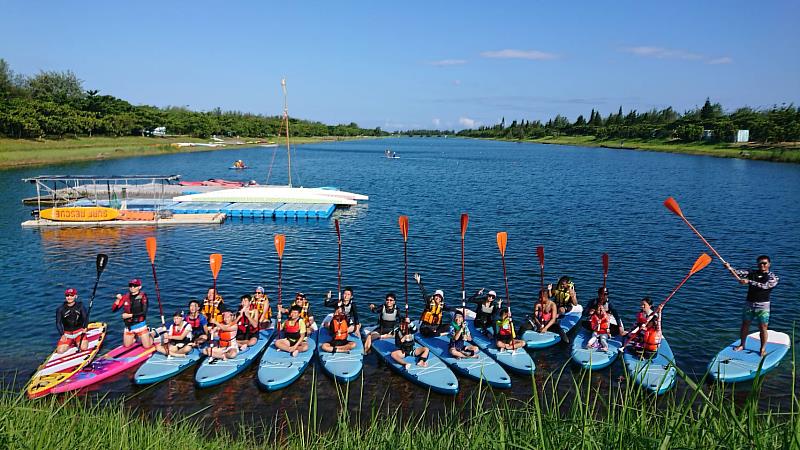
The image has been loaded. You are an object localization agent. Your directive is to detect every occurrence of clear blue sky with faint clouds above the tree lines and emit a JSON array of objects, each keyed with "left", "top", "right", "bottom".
[{"left": 0, "top": 0, "right": 800, "bottom": 130}]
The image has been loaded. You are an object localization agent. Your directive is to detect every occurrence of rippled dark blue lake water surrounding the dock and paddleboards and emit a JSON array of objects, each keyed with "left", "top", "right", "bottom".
[{"left": 0, "top": 138, "right": 800, "bottom": 423}]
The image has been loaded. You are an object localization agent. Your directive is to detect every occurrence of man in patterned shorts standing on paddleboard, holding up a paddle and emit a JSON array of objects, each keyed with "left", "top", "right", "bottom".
[{"left": 725, "top": 255, "right": 779, "bottom": 357}]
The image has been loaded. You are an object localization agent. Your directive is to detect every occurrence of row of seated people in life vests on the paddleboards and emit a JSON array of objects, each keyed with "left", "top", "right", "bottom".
[{"left": 51, "top": 274, "right": 661, "bottom": 368}]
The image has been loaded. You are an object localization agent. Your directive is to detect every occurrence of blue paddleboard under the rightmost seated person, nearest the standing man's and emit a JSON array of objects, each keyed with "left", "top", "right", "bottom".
[{"left": 624, "top": 338, "right": 677, "bottom": 395}]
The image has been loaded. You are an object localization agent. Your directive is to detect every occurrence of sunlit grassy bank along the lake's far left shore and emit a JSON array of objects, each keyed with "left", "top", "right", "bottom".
[{"left": 0, "top": 136, "right": 368, "bottom": 169}]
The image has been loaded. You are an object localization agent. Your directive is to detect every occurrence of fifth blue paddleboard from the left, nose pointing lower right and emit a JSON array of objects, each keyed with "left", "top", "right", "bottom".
[{"left": 363, "top": 327, "right": 458, "bottom": 395}]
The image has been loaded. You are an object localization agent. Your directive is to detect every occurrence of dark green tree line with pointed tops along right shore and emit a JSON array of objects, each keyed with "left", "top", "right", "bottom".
[{"left": 458, "top": 99, "right": 800, "bottom": 143}]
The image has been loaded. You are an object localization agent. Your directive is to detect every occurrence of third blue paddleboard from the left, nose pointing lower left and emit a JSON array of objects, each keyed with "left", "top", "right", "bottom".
[{"left": 258, "top": 331, "right": 317, "bottom": 391}]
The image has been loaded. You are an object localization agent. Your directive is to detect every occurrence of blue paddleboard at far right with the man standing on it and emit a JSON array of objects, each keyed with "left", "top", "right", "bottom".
[{"left": 708, "top": 330, "right": 791, "bottom": 383}]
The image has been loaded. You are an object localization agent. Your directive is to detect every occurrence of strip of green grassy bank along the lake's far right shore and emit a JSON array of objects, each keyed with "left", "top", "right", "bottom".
[{"left": 506, "top": 136, "right": 800, "bottom": 163}]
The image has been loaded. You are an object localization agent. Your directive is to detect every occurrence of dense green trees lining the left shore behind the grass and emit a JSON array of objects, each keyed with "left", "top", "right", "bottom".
[{"left": 0, "top": 59, "right": 388, "bottom": 138}]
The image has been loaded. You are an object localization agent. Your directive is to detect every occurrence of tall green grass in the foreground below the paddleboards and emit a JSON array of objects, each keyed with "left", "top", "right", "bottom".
[{"left": 0, "top": 364, "right": 800, "bottom": 450}]
